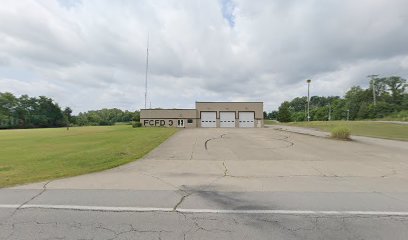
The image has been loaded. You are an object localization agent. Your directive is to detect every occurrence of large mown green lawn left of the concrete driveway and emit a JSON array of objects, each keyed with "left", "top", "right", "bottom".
[{"left": 0, "top": 125, "right": 177, "bottom": 187}]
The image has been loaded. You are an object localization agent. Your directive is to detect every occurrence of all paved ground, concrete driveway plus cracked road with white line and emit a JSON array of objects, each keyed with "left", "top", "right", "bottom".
[{"left": 0, "top": 128, "right": 408, "bottom": 239}]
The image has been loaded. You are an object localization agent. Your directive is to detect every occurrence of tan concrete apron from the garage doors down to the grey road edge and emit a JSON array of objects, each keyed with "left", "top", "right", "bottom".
[{"left": 14, "top": 129, "right": 408, "bottom": 192}]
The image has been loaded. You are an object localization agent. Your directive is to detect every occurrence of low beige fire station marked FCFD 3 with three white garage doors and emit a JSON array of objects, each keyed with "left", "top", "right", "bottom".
[{"left": 140, "top": 102, "right": 264, "bottom": 128}]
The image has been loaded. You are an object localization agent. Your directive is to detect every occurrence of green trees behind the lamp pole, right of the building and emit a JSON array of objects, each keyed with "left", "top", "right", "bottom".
[{"left": 264, "top": 76, "right": 408, "bottom": 122}]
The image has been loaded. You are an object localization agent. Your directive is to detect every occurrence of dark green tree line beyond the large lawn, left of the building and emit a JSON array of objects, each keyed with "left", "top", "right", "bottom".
[{"left": 0, "top": 92, "right": 140, "bottom": 129}]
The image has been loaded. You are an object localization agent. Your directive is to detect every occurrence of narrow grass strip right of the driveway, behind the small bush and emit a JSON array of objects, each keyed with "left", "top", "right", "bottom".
[{"left": 265, "top": 121, "right": 408, "bottom": 141}]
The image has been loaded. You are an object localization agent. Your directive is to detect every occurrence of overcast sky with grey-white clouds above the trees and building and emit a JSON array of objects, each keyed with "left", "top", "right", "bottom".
[{"left": 0, "top": 0, "right": 408, "bottom": 113}]
